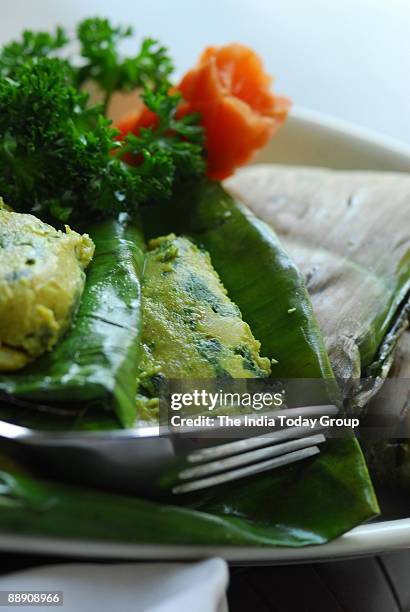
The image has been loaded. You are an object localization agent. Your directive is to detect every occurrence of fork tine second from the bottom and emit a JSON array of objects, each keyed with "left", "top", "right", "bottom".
[{"left": 178, "top": 434, "right": 326, "bottom": 480}]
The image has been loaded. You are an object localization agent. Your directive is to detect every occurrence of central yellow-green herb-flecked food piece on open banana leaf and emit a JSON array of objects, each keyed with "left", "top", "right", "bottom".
[{"left": 135, "top": 234, "right": 270, "bottom": 414}]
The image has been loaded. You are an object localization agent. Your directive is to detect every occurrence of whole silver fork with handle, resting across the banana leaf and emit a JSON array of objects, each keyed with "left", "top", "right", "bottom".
[{"left": 0, "top": 405, "right": 337, "bottom": 499}]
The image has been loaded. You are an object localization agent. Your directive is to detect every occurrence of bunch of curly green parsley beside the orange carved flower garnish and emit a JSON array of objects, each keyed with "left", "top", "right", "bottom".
[{"left": 0, "top": 18, "right": 204, "bottom": 223}]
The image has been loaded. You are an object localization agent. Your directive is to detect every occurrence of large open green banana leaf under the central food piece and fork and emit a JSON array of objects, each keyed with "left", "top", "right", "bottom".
[{"left": 0, "top": 183, "right": 378, "bottom": 546}]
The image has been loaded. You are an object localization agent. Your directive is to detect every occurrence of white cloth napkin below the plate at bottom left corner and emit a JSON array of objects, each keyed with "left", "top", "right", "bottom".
[{"left": 0, "top": 559, "right": 228, "bottom": 612}]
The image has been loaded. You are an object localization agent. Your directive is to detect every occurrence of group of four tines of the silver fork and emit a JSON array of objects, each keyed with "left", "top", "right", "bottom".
[{"left": 172, "top": 405, "right": 338, "bottom": 495}]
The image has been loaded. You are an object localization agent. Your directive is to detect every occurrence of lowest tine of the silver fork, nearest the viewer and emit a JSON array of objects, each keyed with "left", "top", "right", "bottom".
[{"left": 172, "top": 446, "right": 320, "bottom": 495}]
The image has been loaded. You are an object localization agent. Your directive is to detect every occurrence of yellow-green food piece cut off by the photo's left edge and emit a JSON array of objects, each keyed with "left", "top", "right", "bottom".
[{"left": 0, "top": 201, "right": 94, "bottom": 371}]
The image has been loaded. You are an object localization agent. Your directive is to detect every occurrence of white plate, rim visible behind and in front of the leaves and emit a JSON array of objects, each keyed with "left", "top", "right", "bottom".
[{"left": 0, "top": 108, "right": 410, "bottom": 564}]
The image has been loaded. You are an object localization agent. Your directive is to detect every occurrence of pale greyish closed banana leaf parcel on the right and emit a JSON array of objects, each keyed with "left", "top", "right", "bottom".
[{"left": 225, "top": 165, "right": 410, "bottom": 400}]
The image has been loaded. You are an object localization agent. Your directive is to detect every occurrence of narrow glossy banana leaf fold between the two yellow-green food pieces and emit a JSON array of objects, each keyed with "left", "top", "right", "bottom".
[{"left": 0, "top": 219, "right": 144, "bottom": 426}]
